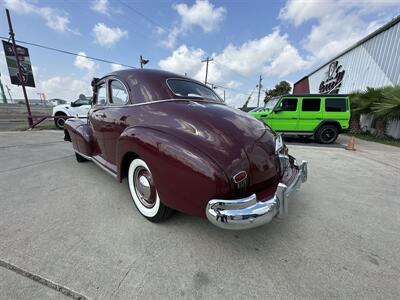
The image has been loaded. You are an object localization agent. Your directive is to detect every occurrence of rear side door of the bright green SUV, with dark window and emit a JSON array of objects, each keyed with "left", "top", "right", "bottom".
[{"left": 299, "top": 97, "right": 322, "bottom": 132}]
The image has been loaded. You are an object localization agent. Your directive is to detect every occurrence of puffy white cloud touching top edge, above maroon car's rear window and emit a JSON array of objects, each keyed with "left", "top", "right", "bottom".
[{"left": 174, "top": 0, "right": 226, "bottom": 32}]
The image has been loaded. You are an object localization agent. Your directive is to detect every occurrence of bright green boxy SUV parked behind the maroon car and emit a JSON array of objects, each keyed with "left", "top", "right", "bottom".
[{"left": 249, "top": 94, "right": 350, "bottom": 144}]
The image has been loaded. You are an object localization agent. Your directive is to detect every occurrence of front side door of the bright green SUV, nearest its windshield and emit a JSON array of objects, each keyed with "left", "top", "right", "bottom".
[{"left": 271, "top": 97, "right": 299, "bottom": 131}]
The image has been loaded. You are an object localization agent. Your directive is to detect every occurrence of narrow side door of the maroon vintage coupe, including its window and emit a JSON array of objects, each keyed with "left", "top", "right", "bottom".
[{"left": 89, "top": 81, "right": 108, "bottom": 159}]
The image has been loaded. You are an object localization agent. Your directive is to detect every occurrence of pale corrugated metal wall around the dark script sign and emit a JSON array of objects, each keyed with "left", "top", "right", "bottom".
[{"left": 309, "top": 23, "right": 400, "bottom": 138}]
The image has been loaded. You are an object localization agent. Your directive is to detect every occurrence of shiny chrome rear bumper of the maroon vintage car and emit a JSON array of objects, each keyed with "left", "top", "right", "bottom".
[{"left": 206, "top": 156, "right": 307, "bottom": 230}]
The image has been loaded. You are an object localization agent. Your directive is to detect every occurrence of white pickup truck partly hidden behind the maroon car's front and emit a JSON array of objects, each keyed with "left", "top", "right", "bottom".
[{"left": 53, "top": 99, "right": 92, "bottom": 129}]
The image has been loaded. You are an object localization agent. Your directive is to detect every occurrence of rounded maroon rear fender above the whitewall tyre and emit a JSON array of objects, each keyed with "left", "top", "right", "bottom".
[{"left": 117, "top": 127, "right": 229, "bottom": 217}]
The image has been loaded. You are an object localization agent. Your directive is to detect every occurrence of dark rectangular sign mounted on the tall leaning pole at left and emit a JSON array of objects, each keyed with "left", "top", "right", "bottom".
[{"left": 2, "top": 41, "right": 35, "bottom": 87}]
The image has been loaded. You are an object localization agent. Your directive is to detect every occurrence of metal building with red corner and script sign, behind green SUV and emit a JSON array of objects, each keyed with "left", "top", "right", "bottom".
[{"left": 293, "top": 16, "right": 400, "bottom": 138}]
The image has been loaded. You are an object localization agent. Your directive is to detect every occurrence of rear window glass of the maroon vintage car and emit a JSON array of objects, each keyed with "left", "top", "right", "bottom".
[{"left": 167, "top": 79, "right": 221, "bottom": 102}]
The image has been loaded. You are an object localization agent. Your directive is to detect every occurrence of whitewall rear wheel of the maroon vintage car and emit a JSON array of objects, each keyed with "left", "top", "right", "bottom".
[{"left": 128, "top": 158, "right": 172, "bottom": 223}]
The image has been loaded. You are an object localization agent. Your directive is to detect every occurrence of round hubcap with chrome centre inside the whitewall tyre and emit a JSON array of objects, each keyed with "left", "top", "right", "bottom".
[{"left": 133, "top": 167, "right": 157, "bottom": 208}]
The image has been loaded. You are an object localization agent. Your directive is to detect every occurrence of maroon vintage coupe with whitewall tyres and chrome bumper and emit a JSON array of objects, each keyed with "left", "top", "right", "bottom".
[{"left": 64, "top": 69, "right": 307, "bottom": 229}]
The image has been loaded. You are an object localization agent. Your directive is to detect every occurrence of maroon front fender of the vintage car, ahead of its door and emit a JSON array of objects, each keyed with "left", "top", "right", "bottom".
[{"left": 64, "top": 118, "right": 93, "bottom": 157}]
